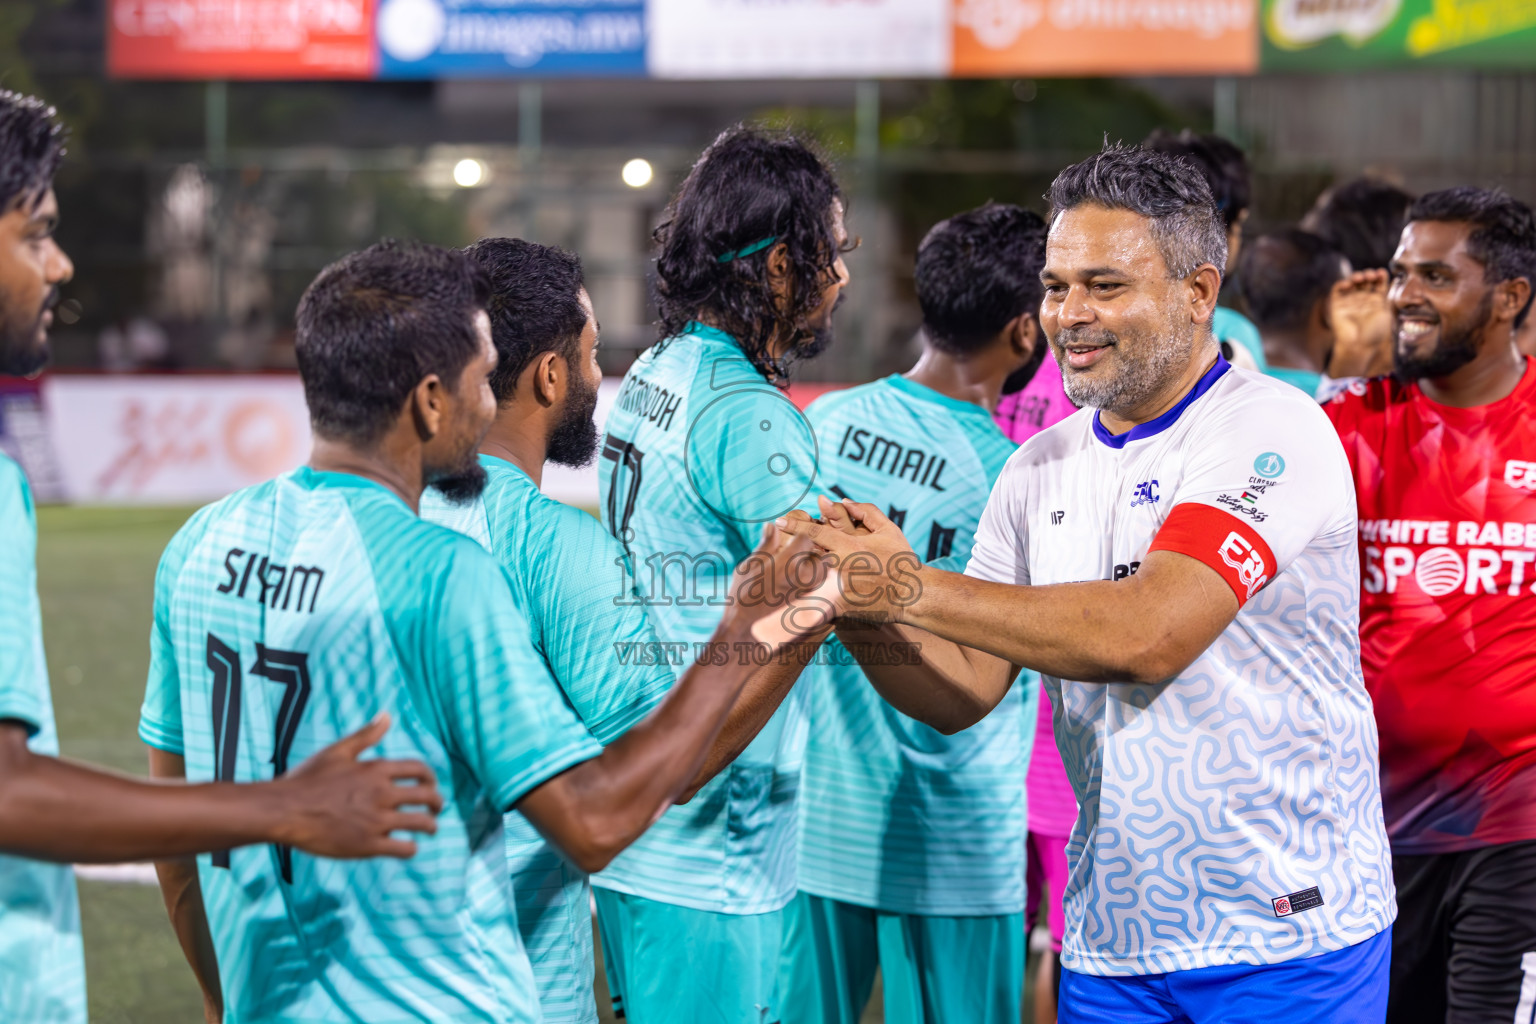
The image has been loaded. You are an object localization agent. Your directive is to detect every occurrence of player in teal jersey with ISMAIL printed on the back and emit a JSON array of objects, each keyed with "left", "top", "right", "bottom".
[{"left": 780, "top": 204, "right": 1046, "bottom": 1024}]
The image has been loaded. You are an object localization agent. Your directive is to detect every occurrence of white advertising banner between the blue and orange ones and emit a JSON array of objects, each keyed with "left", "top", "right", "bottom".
[{"left": 645, "top": 0, "right": 951, "bottom": 78}]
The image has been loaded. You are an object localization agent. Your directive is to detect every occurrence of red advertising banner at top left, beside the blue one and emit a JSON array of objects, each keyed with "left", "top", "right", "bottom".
[{"left": 106, "top": 0, "right": 375, "bottom": 78}]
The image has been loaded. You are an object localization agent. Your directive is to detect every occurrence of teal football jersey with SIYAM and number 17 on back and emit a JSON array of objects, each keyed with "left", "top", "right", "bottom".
[{"left": 140, "top": 468, "right": 601, "bottom": 1024}]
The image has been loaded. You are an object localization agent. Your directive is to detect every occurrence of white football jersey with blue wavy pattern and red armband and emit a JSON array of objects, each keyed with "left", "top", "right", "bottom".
[{"left": 966, "top": 359, "right": 1396, "bottom": 975}]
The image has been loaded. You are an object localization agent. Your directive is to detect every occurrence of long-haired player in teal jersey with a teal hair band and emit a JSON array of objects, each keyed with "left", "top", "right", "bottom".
[{"left": 593, "top": 127, "right": 848, "bottom": 1024}]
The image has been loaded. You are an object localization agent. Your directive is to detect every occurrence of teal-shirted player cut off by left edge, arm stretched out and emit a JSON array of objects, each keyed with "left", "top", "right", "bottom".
[{"left": 0, "top": 92, "right": 438, "bottom": 1024}]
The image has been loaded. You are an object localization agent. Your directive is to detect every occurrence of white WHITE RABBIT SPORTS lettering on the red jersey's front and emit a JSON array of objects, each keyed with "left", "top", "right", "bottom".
[{"left": 1359, "top": 519, "right": 1536, "bottom": 597}]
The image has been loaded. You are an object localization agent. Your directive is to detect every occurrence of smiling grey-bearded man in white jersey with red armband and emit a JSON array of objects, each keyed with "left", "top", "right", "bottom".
[{"left": 782, "top": 146, "right": 1395, "bottom": 1024}]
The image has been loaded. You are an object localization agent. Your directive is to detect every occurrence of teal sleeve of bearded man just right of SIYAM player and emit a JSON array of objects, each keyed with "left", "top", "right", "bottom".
[{"left": 521, "top": 507, "right": 674, "bottom": 745}]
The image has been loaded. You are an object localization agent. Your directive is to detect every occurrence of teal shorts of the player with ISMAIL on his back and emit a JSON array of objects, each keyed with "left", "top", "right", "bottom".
[{"left": 779, "top": 892, "right": 1026, "bottom": 1024}]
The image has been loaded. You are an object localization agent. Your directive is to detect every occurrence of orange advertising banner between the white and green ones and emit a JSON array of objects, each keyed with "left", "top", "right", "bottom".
[{"left": 952, "top": 0, "right": 1258, "bottom": 78}]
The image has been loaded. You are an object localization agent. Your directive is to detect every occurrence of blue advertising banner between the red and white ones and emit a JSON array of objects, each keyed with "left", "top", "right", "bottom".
[{"left": 378, "top": 0, "right": 645, "bottom": 78}]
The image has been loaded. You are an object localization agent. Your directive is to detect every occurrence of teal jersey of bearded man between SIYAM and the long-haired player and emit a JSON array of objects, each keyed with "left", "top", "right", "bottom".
[{"left": 421, "top": 454, "right": 674, "bottom": 1024}]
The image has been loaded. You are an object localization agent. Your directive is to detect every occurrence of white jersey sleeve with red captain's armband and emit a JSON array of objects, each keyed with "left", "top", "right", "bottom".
[{"left": 1149, "top": 395, "right": 1355, "bottom": 606}]
